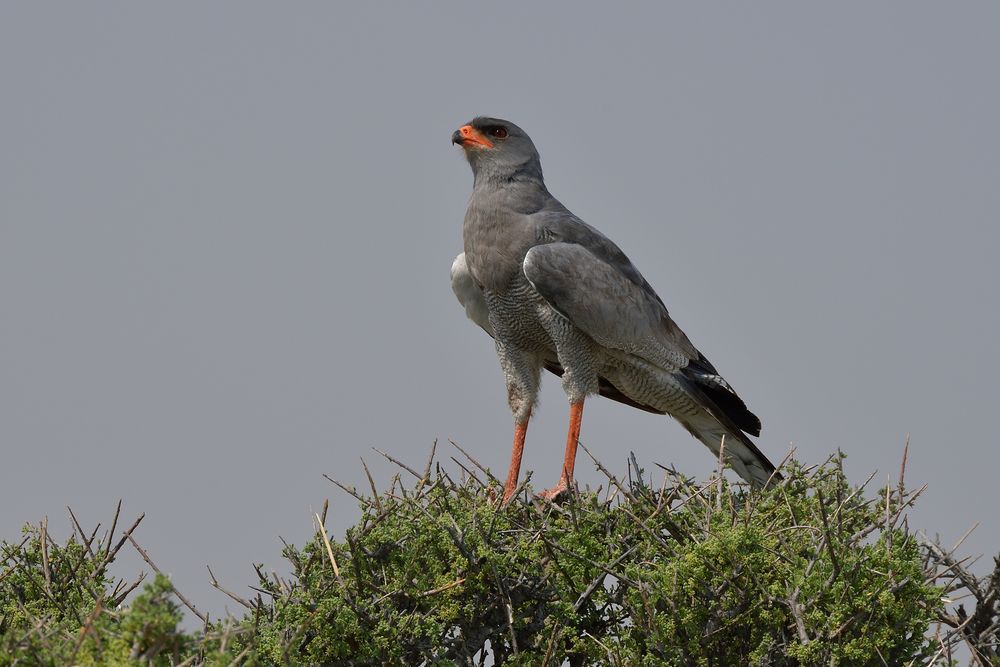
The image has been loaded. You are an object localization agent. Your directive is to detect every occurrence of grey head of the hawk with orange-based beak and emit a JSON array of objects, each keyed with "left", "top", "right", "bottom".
[{"left": 451, "top": 116, "right": 542, "bottom": 179}]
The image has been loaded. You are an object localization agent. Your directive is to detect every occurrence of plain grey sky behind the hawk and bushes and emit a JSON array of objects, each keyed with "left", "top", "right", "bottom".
[{"left": 0, "top": 2, "right": 1000, "bottom": 624}]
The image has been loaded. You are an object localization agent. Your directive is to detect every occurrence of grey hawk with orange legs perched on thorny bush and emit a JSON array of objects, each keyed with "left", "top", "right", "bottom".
[{"left": 451, "top": 116, "right": 780, "bottom": 505}]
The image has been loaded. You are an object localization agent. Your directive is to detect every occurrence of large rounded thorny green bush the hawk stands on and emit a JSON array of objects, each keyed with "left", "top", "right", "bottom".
[{"left": 236, "top": 460, "right": 941, "bottom": 665}]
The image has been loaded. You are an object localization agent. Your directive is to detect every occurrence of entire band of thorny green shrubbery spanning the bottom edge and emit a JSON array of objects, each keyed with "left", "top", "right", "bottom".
[{"left": 0, "top": 458, "right": 1000, "bottom": 666}]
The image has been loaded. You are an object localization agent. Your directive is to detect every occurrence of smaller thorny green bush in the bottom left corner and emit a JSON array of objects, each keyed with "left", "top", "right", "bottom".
[{"left": 0, "top": 522, "right": 237, "bottom": 667}]
